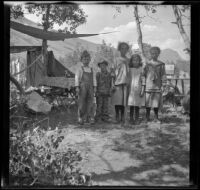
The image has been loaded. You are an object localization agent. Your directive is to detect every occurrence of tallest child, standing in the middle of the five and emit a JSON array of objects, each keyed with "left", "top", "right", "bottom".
[{"left": 112, "top": 42, "right": 129, "bottom": 123}]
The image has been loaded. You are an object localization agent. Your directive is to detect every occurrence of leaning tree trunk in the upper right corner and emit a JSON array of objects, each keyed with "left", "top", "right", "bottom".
[{"left": 172, "top": 5, "right": 190, "bottom": 53}]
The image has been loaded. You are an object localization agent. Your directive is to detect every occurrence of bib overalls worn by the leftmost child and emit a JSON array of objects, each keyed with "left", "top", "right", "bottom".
[{"left": 78, "top": 67, "right": 94, "bottom": 120}]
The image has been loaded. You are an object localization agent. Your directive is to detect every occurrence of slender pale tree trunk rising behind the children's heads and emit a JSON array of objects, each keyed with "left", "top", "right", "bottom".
[{"left": 134, "top": 5, "right": 145, "bottom": 59}]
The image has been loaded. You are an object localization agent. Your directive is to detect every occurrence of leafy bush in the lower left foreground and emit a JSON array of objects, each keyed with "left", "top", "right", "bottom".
[{"left": 9, "top": 126, "right": 90, "bottom": 185}]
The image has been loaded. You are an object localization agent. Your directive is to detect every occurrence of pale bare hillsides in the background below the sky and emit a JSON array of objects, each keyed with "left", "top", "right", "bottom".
[{"left": 10, "top": 18, "right": 190, "bottom": 72}]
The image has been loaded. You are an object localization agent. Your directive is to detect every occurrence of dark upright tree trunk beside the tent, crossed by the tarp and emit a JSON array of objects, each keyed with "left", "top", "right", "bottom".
[{"left": 42, "top": 4, "right": 50, "bottom": 76}]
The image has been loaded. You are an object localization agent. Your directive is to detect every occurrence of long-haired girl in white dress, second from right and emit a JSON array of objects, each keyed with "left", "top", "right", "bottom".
[{"left": 128, "top": 54, "right": 145, "bottom": 125}]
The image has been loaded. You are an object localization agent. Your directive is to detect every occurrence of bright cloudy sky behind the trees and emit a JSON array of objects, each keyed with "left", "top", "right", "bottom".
[{"left": 7, "top": 3, "right": 190, "bottom": 60}]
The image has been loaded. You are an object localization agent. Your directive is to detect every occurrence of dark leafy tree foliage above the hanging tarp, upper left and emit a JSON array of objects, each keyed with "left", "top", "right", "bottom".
[{"left": 11, "top": 3, "right": 87, "bottom": 33}]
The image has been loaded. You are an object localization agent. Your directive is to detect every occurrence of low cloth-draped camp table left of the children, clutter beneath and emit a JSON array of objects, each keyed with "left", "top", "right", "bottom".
[{"left": 40, "top": 77, "right": 76, "bottom": 108}]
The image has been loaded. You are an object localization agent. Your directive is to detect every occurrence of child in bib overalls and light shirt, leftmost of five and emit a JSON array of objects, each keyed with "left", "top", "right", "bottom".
[{"left": 75, "top": 50, "right": 97, "bottom": 125}]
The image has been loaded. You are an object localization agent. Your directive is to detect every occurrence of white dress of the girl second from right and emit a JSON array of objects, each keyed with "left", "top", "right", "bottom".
[{"left": 128, "top": 67, "right": 145, "bottom": 107}]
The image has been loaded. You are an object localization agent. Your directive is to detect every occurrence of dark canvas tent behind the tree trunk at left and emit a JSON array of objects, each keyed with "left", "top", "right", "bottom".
[{"left": 26, "top": 51, "right": 75, "bottom": 87}]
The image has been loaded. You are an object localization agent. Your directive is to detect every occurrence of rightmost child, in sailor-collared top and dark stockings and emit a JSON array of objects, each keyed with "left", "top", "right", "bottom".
[{"left": 141, "top": 47, "right": 166, "bottom": 122}]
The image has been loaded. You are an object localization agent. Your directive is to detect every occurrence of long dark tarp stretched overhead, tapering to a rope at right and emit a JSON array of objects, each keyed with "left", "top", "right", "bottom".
[{"left": 10, "top": 21, "right": 117, "bottom": 41}]
